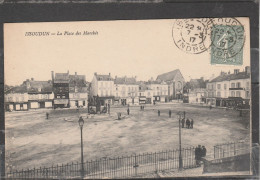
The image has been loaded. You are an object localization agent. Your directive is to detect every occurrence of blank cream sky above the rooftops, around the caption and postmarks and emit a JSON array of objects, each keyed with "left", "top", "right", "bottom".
[{"left": 4, "top": 18, "right": 250, "bottom": 85}]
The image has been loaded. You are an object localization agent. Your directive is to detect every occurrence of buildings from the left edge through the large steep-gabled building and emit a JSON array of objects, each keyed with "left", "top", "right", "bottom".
[{"left": 5, "top": 69, "right": 185, "bottom": 111}]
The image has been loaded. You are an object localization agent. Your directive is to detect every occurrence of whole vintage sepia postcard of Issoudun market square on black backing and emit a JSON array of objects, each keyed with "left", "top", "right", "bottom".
[{"left": 4, "top": 17, "right": 254, "bottom": 179}]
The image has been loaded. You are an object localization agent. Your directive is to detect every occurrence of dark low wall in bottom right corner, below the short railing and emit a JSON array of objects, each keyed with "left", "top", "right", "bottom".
[{"left": 203, "top": 153, "right": 250, "bottom": 173}]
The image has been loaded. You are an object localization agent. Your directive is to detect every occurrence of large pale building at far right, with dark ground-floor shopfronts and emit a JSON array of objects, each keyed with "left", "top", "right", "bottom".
[{"left": 207, "top": 66, "right": 251, "bottom": 108}]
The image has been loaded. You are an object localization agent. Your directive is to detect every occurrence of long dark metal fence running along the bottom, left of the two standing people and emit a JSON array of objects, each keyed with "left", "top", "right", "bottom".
[{"left": 6, "top": 147, "right": 196, "bottom": 179}]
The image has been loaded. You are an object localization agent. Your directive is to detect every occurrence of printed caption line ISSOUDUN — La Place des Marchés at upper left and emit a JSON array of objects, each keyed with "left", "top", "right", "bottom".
[{"left": 25, "top": 31, "right": 98, "bottom": 36}]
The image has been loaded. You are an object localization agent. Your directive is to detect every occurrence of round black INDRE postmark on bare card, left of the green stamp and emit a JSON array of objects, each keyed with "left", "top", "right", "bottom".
[{"left": 172, "top": 18, "right": 213, "bottom": 54}]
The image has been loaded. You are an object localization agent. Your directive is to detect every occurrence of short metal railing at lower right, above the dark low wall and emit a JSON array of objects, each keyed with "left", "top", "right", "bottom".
[{"left": 214, "top": 141, "right": 250, "bottom": 159}]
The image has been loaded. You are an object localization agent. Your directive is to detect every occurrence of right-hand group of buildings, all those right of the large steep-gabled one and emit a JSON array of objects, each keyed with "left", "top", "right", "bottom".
[{"left": 184, "top": 66, "right": 251, "bottom": 108}]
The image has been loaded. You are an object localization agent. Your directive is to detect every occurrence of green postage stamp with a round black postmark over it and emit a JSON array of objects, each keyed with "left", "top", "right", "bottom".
[{"left": 210, "top": 18, "right": 245, "bottom": 65}]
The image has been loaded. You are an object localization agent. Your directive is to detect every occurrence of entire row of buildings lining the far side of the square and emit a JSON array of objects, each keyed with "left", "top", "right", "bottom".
[{"left": 5, "top": 66, "right": 251, "bottom": 111}]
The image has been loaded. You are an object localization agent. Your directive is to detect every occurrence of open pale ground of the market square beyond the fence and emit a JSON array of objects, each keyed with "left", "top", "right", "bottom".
[{"left": 5, "top": 103, "right": 249, "bottom": 174}]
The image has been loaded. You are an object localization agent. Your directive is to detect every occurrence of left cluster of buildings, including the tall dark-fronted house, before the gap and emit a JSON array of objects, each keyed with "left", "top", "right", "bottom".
[{"left": 5, "top": 72, "right": 88, "bottom": 111}]
